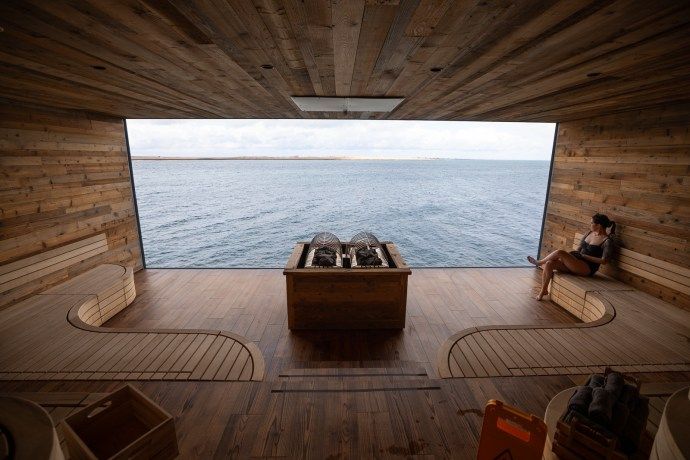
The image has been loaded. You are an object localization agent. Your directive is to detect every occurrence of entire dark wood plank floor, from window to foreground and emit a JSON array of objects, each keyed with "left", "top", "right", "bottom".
[{"left": 0, "top": 268, "right": 690, "bottom": 458}]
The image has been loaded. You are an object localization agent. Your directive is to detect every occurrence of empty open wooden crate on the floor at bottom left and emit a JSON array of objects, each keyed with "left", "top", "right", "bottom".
[{"left": 63, "top": 385, "right": 178, "bottom": 460}]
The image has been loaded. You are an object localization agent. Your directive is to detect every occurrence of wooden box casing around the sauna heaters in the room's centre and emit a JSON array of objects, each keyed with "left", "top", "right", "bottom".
[{"left": 283, "top": 242, "right": 412, "bottom": 329}]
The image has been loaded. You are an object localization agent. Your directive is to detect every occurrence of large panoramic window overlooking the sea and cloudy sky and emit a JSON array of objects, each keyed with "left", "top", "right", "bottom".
[{"left": 128, "top": 120, "right": 554, "bottom": 267}]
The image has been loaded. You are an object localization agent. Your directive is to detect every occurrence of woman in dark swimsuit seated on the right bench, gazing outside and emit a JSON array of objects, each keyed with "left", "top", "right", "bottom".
[{"left": 527, "top": 213, "right": 616, "bottom": 300}]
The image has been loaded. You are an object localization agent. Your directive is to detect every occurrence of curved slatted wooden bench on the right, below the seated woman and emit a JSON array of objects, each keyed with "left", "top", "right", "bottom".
[{"left": 437, "top": 288, "right": 690, "bottom": 378}]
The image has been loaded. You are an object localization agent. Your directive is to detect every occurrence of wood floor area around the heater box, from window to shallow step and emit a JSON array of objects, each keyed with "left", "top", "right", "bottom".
[{"left": 107, "top": 268, "right": 576, "bottom": 379}]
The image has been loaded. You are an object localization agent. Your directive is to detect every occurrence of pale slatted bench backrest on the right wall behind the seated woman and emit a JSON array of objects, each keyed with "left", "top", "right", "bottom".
[{"left": 573, "top": 233, "right": 690, "bottom": 295}]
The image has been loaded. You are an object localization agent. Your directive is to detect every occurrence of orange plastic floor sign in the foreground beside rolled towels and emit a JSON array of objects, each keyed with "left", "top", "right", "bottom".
[{"left": 477, "top": 399, "right": 546, "bottom": 460}]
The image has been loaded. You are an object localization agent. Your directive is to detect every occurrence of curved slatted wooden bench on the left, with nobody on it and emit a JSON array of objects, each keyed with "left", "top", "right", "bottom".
[{"left": 0, "top": 265, "right": 264, "bottom": 381}]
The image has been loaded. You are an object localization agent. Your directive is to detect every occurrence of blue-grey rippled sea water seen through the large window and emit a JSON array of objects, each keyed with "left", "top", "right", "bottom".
[{"left": 133, "top": 160, "right": 549, "bottom": 268}]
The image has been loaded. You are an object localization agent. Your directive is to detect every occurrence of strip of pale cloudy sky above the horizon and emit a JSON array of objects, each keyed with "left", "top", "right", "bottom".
[{"left": 127, "top": 119, "right": 555, "bottom": 161}]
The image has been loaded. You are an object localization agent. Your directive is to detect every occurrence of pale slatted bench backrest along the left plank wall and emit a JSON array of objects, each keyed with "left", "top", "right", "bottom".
[{"left": 0, "top": 233, "right": 108, "bottom": 306}]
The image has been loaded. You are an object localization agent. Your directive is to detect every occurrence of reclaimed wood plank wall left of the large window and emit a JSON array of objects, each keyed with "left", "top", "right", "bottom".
[{"left": 0, "top": 100, "right": 142, "bottom": 309}]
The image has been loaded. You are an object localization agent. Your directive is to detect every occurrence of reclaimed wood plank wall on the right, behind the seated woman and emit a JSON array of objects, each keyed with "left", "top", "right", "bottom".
[{"left": 541, "top": 102, "right": 690, "bottom": 309}]
